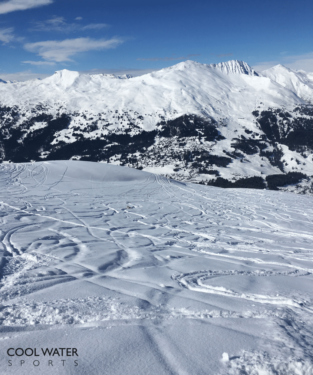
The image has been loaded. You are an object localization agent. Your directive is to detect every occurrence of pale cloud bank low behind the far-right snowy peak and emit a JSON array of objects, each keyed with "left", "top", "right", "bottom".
[{"left": 253, "top": 52, "right": 313, "bottom": 72}]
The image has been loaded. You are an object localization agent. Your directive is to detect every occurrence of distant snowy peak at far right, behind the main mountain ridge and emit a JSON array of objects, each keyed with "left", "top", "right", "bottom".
[{"left": 261, "top": 65, "right": 313, "bottom": 103}]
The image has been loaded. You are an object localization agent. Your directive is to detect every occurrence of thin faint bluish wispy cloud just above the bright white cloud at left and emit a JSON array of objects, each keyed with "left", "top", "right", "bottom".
[{"left": 30, "top": 16, "right": 109, "bottom": 33}]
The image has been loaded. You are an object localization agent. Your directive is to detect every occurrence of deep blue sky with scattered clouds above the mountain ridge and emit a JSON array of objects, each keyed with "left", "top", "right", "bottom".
[{"left": 0, "top": 0, "right": 313, "bottom": 81}]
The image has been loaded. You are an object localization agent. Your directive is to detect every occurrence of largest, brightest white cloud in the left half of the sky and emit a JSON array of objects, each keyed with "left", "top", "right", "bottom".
[{"left": 24, "top": 38, "right": 123, "bottom": 62}]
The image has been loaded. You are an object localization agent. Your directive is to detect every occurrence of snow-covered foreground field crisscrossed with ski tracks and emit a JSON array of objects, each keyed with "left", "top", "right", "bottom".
[{"left": 0, "top": 161, "right": 313, "bottom": 375}]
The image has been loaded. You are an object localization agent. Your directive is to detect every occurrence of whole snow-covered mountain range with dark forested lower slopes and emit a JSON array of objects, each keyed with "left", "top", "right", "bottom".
[{"left": 0, "top": 61, "right": 313, "bottom": 192}]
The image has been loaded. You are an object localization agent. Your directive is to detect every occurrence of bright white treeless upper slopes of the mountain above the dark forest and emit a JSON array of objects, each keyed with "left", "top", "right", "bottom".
[{"left": 0, "top": 61, "right": 303, "bottom": 120}]
